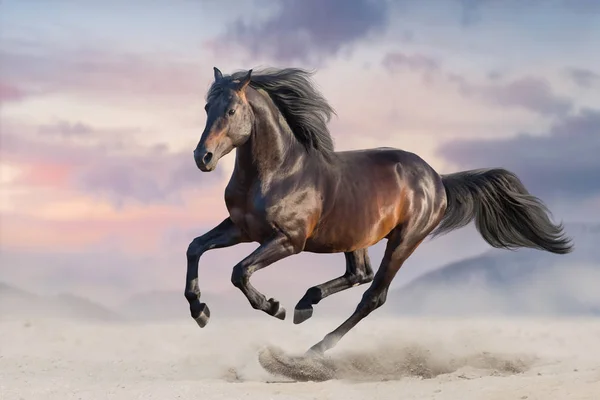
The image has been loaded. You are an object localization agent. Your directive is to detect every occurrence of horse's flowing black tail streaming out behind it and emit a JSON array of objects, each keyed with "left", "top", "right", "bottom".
[{"left": 432, "top": 168, "right": 573, "bottom": 254}]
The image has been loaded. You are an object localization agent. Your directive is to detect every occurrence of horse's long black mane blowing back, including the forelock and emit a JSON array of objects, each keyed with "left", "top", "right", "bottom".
[{"left": 209, "top": 68, "right": 335, "bottom": 155}]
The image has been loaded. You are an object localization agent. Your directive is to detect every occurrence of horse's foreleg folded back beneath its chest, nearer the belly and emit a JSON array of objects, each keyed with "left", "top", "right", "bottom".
[{"left": 231, "top": 235, "right": 299, "bottom": 319}]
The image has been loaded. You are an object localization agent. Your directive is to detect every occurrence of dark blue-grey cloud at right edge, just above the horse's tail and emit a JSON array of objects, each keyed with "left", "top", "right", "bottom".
[{"left": 439, "top": 109, "right": 600, "bottom": 200}]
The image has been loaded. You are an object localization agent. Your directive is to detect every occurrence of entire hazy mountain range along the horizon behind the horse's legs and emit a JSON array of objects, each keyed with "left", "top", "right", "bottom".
[{"left": 0, "top": 224, "right": 600, "bottom": 321}]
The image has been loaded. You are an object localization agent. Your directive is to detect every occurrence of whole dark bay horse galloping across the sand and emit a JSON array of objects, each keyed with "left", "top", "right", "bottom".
[{"left": 184, "top": 67, "right": 573, "bottom": 355}]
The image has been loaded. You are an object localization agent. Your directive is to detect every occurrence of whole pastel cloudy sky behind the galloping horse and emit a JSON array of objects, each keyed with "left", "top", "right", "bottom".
[{"left": 0, "top": 0, "right": 600, "bottom": 306}]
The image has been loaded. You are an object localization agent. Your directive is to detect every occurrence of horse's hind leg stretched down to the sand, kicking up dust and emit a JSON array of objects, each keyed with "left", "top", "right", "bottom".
[{"left": 308, "top": 227, "right": 429, "bottom": 354}]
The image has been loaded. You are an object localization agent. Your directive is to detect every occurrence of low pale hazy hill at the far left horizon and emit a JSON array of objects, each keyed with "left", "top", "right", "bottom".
[{"left": 0, "top": 282, "right": 122, "bottom": 321}]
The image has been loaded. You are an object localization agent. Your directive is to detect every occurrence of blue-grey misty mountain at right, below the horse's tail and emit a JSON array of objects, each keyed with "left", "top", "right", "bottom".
[{"left": 387, "top": 224, "right": 600, "bottom": 316}]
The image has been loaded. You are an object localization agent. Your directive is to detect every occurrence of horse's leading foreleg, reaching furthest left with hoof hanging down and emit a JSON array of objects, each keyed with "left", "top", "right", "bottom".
[{"left": 185, "top": 218, "right": 247, "bottom": 328}]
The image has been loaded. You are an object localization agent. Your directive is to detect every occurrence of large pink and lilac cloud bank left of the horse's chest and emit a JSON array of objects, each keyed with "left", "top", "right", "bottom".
[{"left": 0, "top": 119, "right": 227, "bottom": 254}]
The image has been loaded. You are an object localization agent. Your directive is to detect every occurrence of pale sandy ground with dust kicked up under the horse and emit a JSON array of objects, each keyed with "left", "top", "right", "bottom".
[{"left": 0, "top": 315, "right": 600, "bottom": 400}]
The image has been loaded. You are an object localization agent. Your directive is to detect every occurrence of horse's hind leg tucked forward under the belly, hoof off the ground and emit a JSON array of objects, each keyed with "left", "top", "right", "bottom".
[{"left": 294, "top": 249, "right": 373, "bottom": 324}]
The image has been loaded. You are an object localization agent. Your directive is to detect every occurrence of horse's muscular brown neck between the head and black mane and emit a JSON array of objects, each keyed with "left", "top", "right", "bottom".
[{"left": 234, "top": 92, "right": 306, "bottom": 180}]
